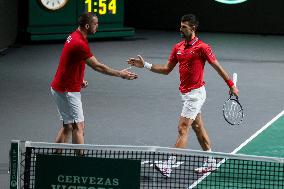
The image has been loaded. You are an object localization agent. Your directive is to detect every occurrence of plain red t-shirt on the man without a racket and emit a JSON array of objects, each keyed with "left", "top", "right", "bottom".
[{"left": 51, "top": 30, "right": 93, "bottom": 92}]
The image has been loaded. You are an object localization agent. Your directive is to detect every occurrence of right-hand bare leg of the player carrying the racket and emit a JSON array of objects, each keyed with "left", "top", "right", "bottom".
[{"left": 192, "top": 113, "right": 211, "bottom": 151}]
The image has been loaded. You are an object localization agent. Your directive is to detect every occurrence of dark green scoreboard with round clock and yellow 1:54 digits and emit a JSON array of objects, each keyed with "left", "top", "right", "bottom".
[{"left": 19, "top": 0, "right": 134, "bottom": 41}]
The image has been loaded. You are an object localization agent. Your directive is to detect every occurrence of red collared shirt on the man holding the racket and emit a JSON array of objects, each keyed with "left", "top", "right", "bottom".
[{"left": 169, "top": 37, "right": 216, "bottom": 93}]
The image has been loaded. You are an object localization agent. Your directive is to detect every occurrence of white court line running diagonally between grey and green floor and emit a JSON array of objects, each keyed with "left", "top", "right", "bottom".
[{"left": 187, "top": 110, "right": 284, "bottom": 189}]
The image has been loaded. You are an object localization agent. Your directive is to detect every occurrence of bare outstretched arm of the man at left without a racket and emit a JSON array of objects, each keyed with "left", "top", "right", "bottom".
[{"left": 86, "top": 56, "right": 137, "bottom": 80}]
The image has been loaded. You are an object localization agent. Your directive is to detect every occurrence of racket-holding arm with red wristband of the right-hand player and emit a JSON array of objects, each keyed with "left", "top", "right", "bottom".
[{"left": 210, "top": 59, "right": 239, "bottom": 96}]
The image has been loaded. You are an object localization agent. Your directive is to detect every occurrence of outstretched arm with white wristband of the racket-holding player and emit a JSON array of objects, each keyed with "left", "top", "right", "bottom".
[{"left": 127, "top": 55, "right": 176, "bottom": 75}]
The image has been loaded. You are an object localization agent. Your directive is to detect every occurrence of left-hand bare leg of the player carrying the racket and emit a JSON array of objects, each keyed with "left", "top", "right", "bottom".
[{"left": 175, "top": 116, "right": 193, "bottom": 148}]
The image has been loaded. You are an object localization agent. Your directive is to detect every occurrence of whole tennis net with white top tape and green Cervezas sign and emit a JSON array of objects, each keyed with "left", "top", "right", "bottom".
[{"left": 10, "top": 141, "right": 284, "bottom": 189}]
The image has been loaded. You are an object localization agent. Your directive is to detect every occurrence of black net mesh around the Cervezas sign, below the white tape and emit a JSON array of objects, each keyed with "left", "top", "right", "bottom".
[{"left": 18, "top": 143, "right": 284, "bottom": 189}]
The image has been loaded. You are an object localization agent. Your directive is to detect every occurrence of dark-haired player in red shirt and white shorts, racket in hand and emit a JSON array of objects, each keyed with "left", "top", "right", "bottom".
[{"left": 128, "top": 14, "right": 238, "bottom": 176}]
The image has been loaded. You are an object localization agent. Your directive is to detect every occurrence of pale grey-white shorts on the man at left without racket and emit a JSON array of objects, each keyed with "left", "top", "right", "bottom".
[{"left": 51, "top": 88, "right": 84, "bottom": 124}]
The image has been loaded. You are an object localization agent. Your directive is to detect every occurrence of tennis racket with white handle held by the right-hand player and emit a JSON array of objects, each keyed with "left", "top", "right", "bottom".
[{"left": 223, "top": 73, "right": 244, "bottom": 125}]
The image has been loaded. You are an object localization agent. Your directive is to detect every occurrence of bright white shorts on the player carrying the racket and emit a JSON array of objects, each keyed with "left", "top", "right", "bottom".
[{"left": 181, "top": 86, "right": 206, "bottom": 120}]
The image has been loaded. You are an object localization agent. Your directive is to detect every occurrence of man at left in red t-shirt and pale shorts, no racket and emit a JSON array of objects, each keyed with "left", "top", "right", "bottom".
[{"left": 51, "top": 13, "right": 137, "bottom": 152}]
